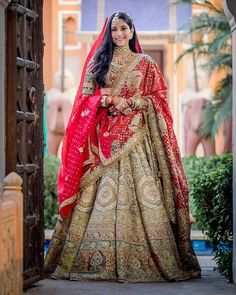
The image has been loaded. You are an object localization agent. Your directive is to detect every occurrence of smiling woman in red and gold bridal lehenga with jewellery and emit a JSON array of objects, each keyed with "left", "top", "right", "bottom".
[{"left": 45, "top": 12, "right": 200, "bottom": 282}]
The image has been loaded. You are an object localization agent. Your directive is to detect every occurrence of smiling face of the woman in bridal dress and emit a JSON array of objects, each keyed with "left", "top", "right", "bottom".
[{"left": 111, "top": 19, "right": 133, "bottom": 47}]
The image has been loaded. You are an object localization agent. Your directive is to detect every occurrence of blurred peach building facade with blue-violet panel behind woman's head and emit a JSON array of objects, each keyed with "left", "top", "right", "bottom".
[{"left": 44, "top": 0, "right": 192, "bottom": 152}]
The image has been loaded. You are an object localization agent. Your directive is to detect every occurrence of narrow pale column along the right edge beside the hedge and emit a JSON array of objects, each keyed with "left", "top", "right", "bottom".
[{"left": 223, "top": 0, "right": 236, "bottom": 284}]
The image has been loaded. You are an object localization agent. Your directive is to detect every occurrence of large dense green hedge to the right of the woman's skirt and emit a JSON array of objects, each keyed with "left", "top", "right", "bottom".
[{"left": 184, "top": 154, "right": 233, "bottom": 280}]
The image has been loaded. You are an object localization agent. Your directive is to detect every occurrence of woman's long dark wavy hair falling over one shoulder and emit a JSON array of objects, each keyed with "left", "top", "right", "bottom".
[{"left": 92, "top": 12, "right": 137, "bottom": 87}]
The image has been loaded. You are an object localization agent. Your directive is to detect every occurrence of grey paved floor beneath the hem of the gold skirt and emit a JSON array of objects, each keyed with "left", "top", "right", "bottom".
[{"left": 24, "top": 256, "right": 236, "bottom": 295}]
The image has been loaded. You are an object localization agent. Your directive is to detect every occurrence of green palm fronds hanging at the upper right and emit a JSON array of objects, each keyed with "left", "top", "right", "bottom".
[{"left": 176, "top": 0, "right": 232, "bottom": 146}]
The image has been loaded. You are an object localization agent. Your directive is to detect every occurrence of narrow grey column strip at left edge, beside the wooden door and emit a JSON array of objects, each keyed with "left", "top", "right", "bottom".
[{"left": 0, "top": 0, "right": 10, "bottom": 181}]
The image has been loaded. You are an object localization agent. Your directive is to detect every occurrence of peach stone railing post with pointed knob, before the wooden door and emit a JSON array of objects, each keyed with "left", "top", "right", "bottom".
[{"left": 0, "top": 172, "right": 23, "bottom": 295}]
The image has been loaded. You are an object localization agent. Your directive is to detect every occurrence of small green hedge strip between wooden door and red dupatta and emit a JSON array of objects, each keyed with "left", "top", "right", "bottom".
[{"left": 44, "top": 156, "right": 60, "bottom": 229}]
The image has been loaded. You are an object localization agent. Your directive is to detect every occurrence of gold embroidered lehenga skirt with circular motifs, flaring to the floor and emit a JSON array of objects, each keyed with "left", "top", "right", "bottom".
[{"left": 46, "top": 126, "right": 199, "bottom": 282}]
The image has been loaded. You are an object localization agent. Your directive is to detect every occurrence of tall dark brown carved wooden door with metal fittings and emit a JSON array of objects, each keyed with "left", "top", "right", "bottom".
[{"left": 6, "top": 0, "right": 44, "bottom": 287}]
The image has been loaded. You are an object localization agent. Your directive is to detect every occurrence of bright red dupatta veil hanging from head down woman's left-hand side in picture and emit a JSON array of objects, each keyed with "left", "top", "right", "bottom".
[{"left": 58, "top": 19, "right": 108, "bottom": 218}]
